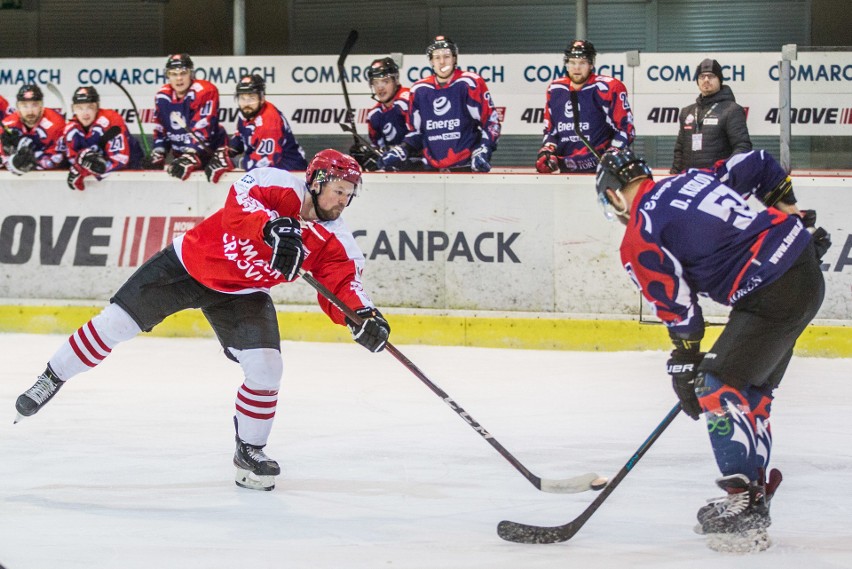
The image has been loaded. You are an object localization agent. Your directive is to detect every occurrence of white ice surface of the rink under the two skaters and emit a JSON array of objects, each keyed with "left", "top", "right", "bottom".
[{"left": 0, "top": 334, "right": 852, "bottom": 569}]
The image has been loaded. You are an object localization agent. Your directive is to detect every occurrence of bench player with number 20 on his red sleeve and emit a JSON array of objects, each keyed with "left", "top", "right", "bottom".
[{"left": 204, "top": 74, "right": 308, "bottom": 184}]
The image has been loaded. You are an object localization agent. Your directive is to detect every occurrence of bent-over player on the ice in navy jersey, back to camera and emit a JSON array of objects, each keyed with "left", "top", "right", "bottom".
[{"left": 596, "top": 149, "right": 831, "bottom": 550}]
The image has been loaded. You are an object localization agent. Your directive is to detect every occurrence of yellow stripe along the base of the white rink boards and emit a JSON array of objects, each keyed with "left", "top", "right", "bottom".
[{"left": 0, "top": 305, "right": 852, "bottom": 358}]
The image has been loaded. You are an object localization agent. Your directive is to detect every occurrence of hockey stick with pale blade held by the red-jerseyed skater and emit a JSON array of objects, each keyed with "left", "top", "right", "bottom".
[{"left": 300, "top": 271, "right": 606, "bottom": 494}]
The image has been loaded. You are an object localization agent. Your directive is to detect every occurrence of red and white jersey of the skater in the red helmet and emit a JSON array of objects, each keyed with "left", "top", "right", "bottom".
[{"left": 174, "top": 168, "right": 373, "bottom": 324}]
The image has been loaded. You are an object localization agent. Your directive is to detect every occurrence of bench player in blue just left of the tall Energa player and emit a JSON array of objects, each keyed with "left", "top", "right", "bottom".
[{"left": 349, "top": 57, "right": 424, "bottom": 172}]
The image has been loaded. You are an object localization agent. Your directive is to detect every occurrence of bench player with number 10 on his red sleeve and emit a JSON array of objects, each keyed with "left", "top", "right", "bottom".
[{"left": 151, "top": 53, "right": 226, "bottom": 180}]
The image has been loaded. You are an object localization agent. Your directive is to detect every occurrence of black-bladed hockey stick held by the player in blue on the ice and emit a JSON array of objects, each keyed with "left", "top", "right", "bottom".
[{"left": 497, "top": 402, "right": 681, "bottom": 543}]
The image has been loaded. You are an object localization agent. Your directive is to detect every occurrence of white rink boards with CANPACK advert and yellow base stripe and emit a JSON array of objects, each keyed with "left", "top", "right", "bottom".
[{"left": 0, "top": 171, "right": 852, "bottom": 352}]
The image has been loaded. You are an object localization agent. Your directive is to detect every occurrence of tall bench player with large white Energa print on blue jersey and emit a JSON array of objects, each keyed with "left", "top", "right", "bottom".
[{"left": 379, "top": 36, "right": 500, "bottom": 172}]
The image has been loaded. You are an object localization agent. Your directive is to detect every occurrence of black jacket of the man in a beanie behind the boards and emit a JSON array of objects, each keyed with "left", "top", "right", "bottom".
[{"left": 671, "top": 85, "right": 751, "bottom": 174}]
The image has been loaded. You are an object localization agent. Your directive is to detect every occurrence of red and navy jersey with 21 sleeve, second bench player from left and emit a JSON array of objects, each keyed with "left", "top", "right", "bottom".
[{"left": 63, "top": 109, "right": 142, "bottom": 172}]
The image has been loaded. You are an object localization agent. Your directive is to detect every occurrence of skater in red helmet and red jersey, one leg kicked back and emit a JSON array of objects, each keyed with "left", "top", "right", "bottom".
[{"left": 15, "top": 150, "right": 390, "bottom": 490}]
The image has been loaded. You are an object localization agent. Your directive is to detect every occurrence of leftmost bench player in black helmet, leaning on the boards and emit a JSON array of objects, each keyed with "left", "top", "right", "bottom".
[{"left": 0, "top": 84, "right": 65, "bottom": 176}]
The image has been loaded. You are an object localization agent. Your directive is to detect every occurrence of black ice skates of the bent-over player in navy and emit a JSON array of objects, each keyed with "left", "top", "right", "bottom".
[{"left": 695, "top": 470, "right": 781, "bottom": 553}]
